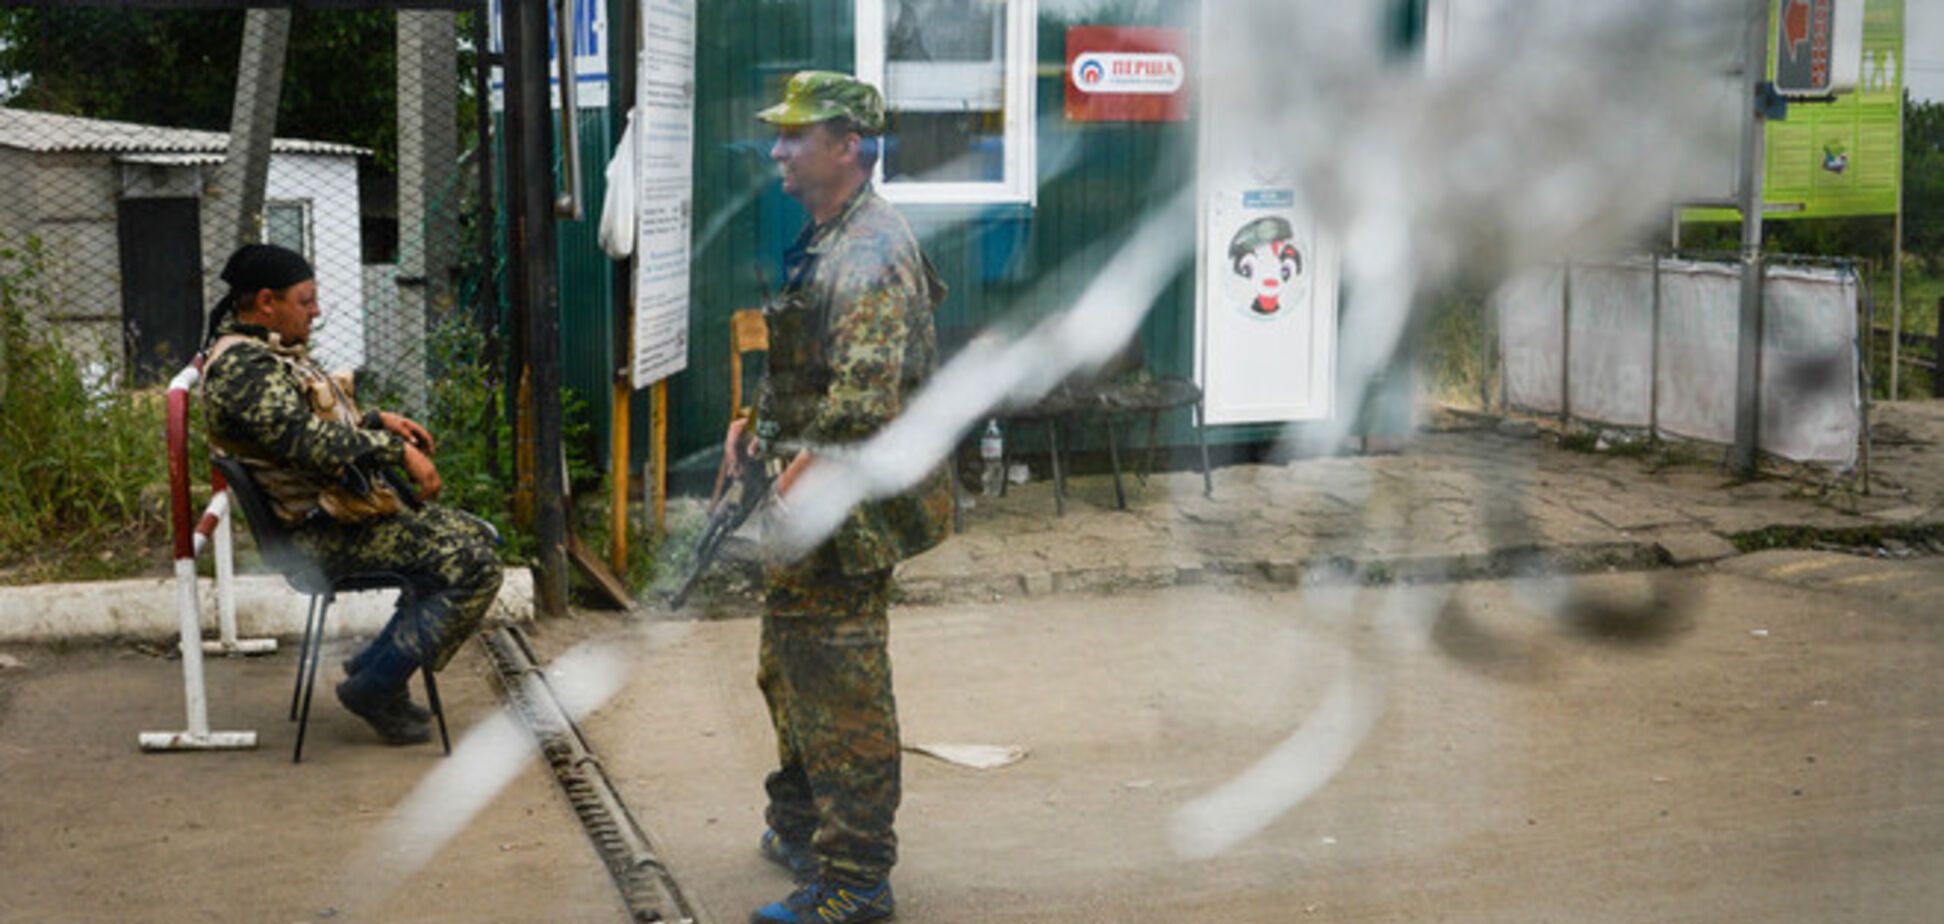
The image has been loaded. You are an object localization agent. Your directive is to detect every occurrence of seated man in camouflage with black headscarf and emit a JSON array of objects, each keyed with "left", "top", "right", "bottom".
[{"left": 202, "top": 243, "right": 502, "bottom": 745}]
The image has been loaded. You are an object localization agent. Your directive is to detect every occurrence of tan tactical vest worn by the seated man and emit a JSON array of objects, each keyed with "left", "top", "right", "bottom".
[{"left": 202, "top": 335, "right": 402, "bottom": 525}]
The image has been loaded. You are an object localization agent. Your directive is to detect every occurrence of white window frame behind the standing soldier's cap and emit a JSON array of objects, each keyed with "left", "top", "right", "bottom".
[{"left": 855, "top": 0, "right": 1040, "bottom": 206}]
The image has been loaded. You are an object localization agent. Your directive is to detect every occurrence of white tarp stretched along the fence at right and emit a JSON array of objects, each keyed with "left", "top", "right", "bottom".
[{"left": 1493, "top": 261, "right": 1862, "bottom": 465}]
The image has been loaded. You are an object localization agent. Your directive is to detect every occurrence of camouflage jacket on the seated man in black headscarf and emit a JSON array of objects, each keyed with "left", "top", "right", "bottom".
[{"left": 202, "top": 319, "right": 404, "bottom": 523}]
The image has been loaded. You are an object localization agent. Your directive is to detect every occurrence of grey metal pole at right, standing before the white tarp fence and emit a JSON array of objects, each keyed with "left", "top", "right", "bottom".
[{"left": 1734, "top": 0, "right": 1773, "bottom": 477}]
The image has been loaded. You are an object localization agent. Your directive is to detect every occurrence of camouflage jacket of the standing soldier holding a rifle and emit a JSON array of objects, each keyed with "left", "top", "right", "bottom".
[{"left": 756, "top": 183, "right": 953, "bottom": 574}]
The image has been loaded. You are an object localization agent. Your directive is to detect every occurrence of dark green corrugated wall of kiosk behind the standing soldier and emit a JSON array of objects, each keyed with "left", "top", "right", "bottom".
[{"left": 636, "top": 0, "right": 1194, "bottom": 476}]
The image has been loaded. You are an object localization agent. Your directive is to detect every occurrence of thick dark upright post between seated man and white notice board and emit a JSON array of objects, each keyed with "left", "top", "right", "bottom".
[{"left": 503, "top": 0, "right": 577, "bottom": 617}]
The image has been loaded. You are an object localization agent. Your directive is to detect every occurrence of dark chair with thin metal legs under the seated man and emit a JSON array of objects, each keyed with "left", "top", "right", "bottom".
[{"left": 210, "top": 455, "right": 453, "bottom": 763}]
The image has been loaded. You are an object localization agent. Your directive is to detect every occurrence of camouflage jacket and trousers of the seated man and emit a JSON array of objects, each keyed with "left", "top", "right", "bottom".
[{"left": 202, "top": 319, "right": 502, "bottom": 669}]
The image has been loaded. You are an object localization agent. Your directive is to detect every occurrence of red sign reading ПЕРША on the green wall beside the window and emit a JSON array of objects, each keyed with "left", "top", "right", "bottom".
[{"left": 1067, "top": 25, "right": 1188, "bottom": 123}]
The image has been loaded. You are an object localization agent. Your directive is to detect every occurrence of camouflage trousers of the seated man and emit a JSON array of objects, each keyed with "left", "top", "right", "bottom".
[{"left": 294, "top": 504, "right": 502, "bottom": 671}]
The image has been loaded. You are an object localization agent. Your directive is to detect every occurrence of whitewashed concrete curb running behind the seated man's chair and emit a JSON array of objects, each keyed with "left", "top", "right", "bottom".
[{"left": 0, "top": 568, "right": 533, "bottom": 642}]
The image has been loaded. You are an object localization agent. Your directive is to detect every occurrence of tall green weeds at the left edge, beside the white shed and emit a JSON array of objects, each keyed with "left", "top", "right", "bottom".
[{"left": 0, "top": 239, "right": 167, "bottom": 574}]
